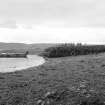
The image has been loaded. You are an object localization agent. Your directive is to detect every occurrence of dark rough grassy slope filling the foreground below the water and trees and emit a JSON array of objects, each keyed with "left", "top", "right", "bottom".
[{"left": 0, "top": 54, "right": 105, "bottom": 105}]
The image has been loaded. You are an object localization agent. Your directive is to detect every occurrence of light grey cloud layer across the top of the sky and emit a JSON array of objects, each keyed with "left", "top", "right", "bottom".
[{"left": 0, "top": 0, "right": 105, "bottom": 27}]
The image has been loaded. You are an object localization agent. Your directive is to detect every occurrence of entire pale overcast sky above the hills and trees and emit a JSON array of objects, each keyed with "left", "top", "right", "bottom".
[{"left": 0, "top": 0, "right": 105, "bottom": 44}]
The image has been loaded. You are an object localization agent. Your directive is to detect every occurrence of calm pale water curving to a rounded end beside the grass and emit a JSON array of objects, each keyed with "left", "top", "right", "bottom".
[{"left": 0, "top": 55, "right": 45, "bottom": 72}]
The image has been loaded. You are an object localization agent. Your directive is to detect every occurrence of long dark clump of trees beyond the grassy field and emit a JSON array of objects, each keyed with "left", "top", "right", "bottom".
[{"left": 42, "top": 44, "right": 105, "bottom": 58}]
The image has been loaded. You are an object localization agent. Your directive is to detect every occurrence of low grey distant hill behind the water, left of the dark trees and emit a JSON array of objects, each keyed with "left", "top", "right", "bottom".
[{"left": 0, "top": 42, "right": 55, "bottom": 54}]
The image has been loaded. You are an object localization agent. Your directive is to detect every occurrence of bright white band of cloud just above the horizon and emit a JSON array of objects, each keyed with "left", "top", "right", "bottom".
[{"left": 0, "top": 26, "right": 105, "bottom": 44}]
